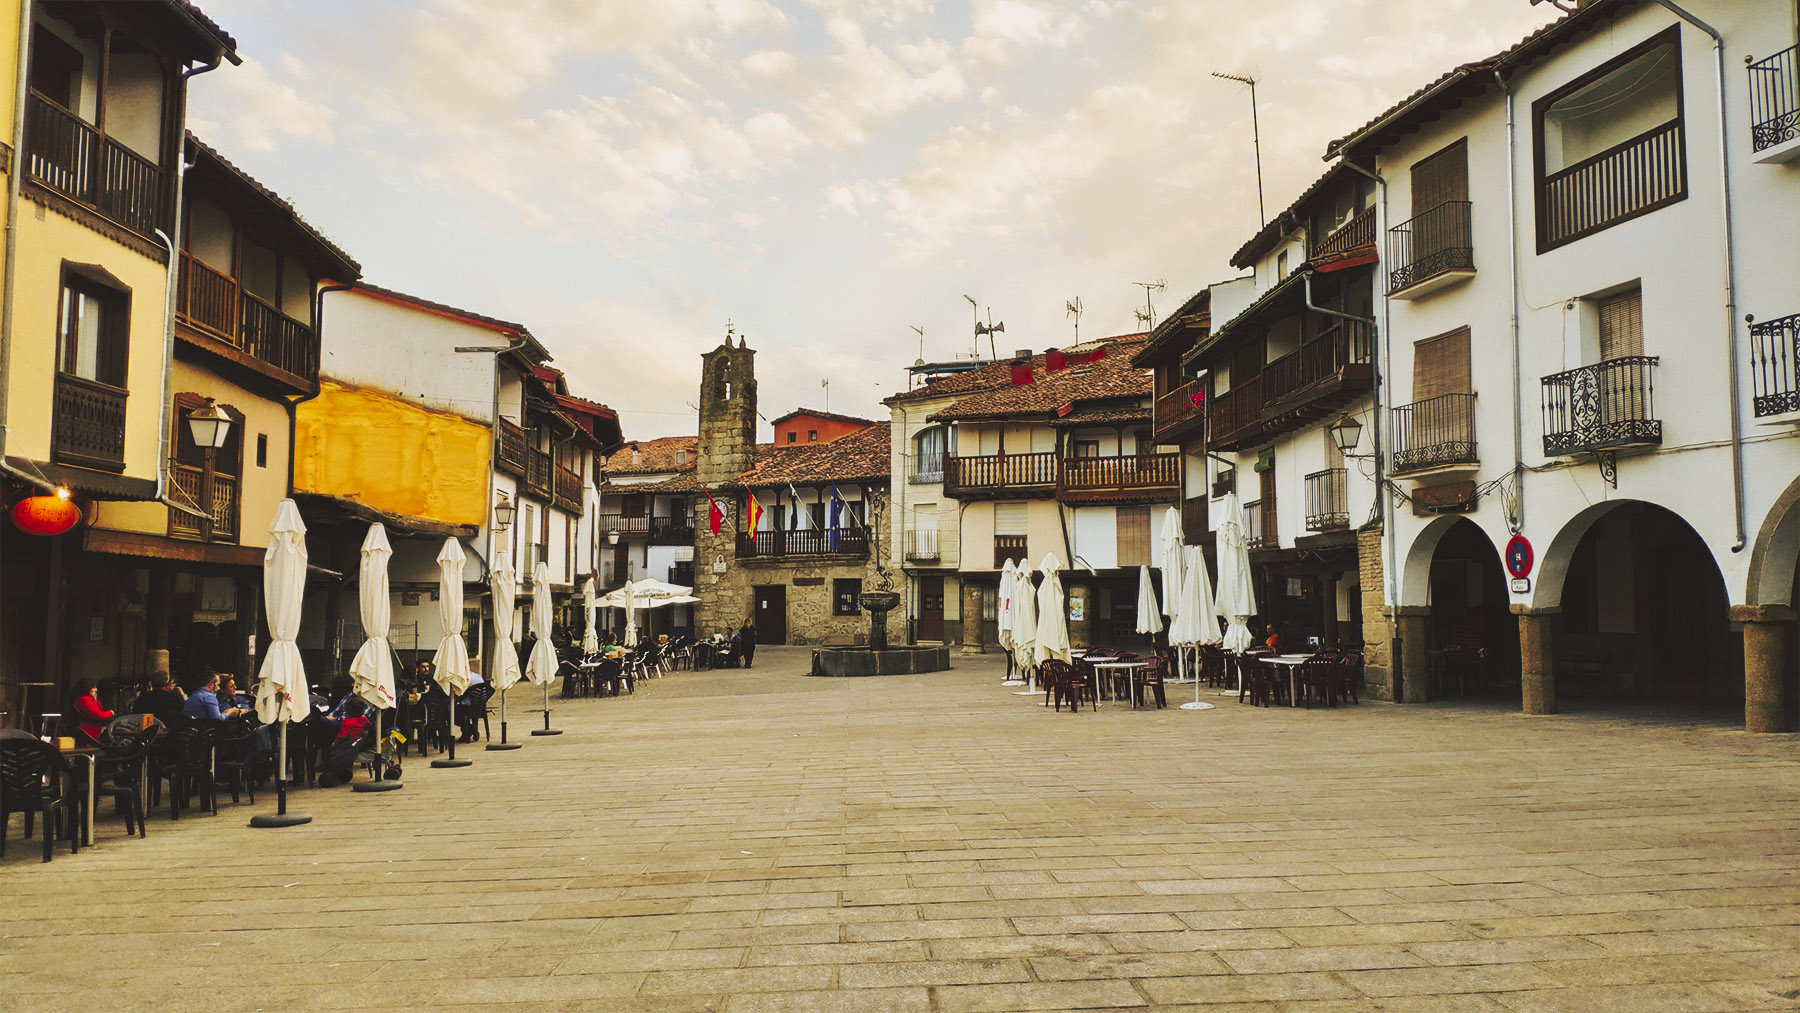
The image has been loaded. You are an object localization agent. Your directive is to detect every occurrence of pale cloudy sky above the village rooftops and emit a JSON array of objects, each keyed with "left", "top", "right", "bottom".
[{"left": 191, "top": 0, "right": 1553, "bottom": 439}]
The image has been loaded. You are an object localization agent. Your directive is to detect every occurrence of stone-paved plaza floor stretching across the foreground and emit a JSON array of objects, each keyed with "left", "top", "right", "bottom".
[{"left": 0, "top": 650, "right": 1800, "bottom": 1013}]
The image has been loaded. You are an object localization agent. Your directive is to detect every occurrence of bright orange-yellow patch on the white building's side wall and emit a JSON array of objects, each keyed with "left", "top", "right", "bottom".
[{"left": 293, "top": 378, "right": 493, "bottom": 525}]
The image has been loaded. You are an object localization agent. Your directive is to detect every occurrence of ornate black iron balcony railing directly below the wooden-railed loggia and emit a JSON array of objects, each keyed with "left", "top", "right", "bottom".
[{"left": 1543, "top": 354, "right": 1663, "bottom": 457}]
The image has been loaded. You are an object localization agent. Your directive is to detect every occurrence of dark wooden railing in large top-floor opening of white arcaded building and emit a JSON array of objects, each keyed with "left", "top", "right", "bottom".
[{"left": 1537, "top": 119, "right": 1687, "bottom": 250}]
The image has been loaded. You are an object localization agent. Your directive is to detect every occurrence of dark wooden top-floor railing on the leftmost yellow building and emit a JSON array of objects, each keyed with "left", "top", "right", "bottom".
[{"left": 25, "top": 92, "right": 164, "bottom": 239}]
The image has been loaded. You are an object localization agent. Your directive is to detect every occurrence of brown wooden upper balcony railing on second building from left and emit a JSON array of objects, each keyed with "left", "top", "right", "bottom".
[{"left": 175, "top": 254, "right": 319, "bottom": 387}]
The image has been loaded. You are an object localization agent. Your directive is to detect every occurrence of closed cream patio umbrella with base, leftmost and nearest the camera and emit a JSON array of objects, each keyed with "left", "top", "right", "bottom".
[{"left": 250, "top": 500, "right": 313, "bottom": 833}]
